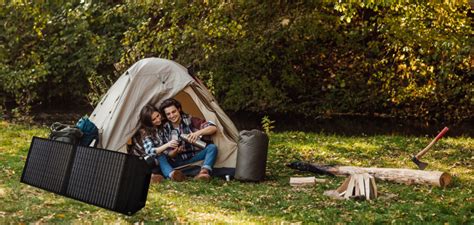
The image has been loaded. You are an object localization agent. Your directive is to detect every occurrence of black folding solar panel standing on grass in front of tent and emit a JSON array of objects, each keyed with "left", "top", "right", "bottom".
[{"left": 21, "top": 137, "right": 151, "bottom": 215}]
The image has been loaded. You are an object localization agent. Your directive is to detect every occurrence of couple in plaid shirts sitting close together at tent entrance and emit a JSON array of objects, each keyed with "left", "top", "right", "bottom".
[{"left": 140, "top": 98, "right": 217, "bottom": 182}]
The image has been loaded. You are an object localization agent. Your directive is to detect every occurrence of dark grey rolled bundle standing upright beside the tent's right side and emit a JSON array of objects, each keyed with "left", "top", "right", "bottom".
[{"left": 235, "top": 129, "right": 268, "bottom": 181}]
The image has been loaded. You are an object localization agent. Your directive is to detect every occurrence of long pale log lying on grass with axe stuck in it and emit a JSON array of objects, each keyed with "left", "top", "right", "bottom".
[{"left": 289, "top": 162, "right": 451, "bottom": 187}]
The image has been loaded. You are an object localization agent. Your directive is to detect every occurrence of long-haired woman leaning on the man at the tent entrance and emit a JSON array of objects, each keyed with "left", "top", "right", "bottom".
[{"left": 140, "top": 104, "right": 185, "bottom": 182}]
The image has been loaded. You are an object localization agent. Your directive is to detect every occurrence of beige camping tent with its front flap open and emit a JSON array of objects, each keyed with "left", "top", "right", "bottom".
[{"left": 90, "top": 58, "right": 239, "bottom": 171}]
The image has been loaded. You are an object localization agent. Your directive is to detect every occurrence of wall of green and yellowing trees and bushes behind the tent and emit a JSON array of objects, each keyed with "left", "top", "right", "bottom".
[{"left": 0, "top": 0, "right": 474, "bottom": 121}]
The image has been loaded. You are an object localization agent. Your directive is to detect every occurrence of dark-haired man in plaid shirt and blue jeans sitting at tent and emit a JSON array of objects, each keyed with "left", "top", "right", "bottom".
[{"left": 159, "top": 98, "right": 217, "bottom": 181}]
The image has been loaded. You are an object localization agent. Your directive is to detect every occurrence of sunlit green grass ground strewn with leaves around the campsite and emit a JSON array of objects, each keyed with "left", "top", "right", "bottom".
[{"left": 0, "top": 121, "right": 474, "bottom": 224}]
